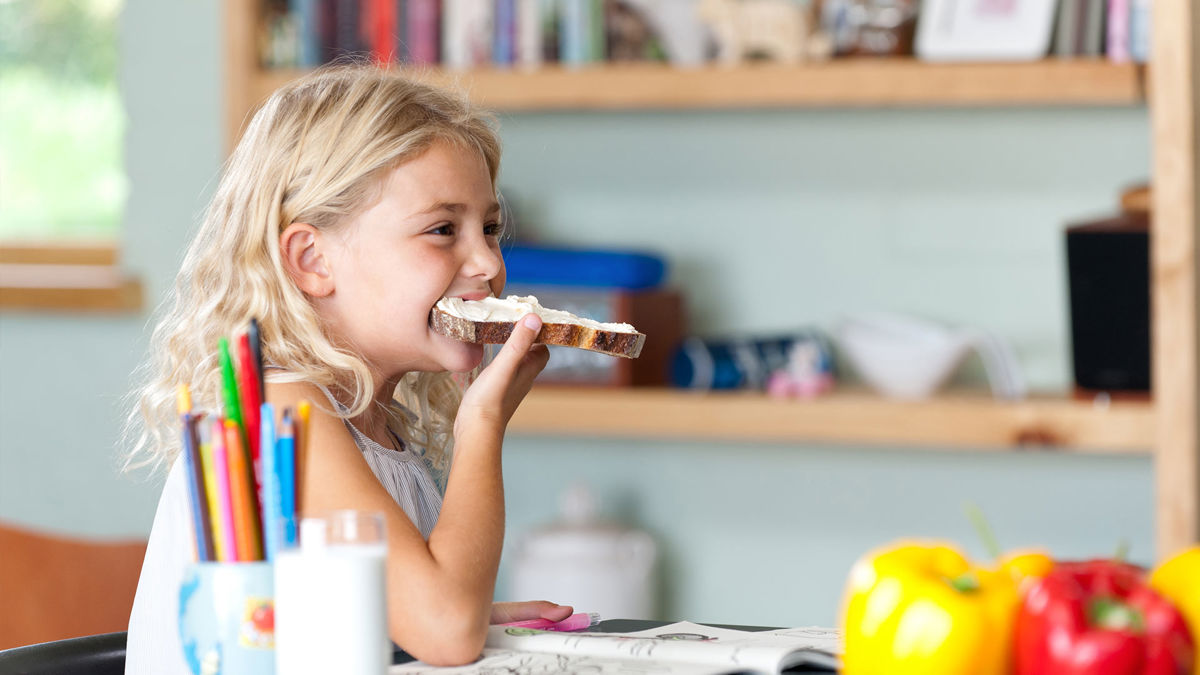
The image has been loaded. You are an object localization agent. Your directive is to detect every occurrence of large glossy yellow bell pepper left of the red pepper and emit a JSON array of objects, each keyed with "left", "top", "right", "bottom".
[{"left": 841, "top": 542, "right": 1054, "bottom": 675}]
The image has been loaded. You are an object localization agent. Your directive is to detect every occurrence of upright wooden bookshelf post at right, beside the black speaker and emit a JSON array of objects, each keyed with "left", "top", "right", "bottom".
[{"left": 1150, "top": 0, "right": 1200, "bottom": 558}]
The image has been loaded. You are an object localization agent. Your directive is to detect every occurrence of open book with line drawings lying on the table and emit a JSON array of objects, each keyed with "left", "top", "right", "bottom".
[{"left": 388, "top": 621, "right": 841, "bottom": 675}]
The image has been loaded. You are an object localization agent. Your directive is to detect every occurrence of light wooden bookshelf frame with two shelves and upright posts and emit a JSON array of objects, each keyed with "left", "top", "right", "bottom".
[{"left": 224, "top": 0, "right": 1200, "bottom": 556}]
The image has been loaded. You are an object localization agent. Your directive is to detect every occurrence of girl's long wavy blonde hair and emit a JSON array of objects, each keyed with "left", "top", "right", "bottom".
[{"left": 125, "top": 64, "right": 500, "bottom": 473}]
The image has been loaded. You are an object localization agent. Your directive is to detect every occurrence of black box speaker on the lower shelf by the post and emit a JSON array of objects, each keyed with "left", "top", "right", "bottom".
[{"left": 1067, "top": 213, "right": 1150, "bottom": 392}]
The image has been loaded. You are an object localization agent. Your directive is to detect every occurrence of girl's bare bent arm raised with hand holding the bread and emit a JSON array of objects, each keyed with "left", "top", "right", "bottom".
[{"left": 268, "top": 317, "right": 553, "bottom": 665}]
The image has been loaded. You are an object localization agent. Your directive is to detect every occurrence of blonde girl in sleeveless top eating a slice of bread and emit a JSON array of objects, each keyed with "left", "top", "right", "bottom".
[{"left": 126, "top": 65, "right": 571, "bottom": 675}]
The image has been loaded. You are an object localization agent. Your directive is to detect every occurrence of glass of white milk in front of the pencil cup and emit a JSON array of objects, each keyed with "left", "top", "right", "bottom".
[{"left": 275, "top": 512, "right": 391, "bottom": 675}]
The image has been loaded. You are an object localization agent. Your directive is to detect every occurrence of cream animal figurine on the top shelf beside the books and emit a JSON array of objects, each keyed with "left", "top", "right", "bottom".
[{"left": 697, "top": 0, "right": 832, "bottom": 66}]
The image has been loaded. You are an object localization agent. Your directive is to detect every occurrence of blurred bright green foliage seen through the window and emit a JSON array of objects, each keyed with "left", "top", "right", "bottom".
[{"left": 0, "top": 0, "right": 127, "bottom": 239}]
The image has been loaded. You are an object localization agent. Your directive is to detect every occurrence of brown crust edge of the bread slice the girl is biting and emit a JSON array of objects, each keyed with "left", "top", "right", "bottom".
[{"left": 430, "top": 307, "right": 646, "bottom": 359}]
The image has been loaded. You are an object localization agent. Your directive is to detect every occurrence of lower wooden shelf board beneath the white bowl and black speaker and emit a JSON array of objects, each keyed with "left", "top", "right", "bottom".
[{"left": 509, "top": 386, "right": 1154, "bottom": 453}]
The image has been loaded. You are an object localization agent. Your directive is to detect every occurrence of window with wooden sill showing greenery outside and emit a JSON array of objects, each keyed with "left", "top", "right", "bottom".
[{"left": 0, "top": 0, "right": 140, "bottom": 310}]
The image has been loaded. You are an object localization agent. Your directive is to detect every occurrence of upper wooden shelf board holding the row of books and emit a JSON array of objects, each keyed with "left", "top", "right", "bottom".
[{"left": 251, "top": 58, "right": 1146, "bottom": 110}]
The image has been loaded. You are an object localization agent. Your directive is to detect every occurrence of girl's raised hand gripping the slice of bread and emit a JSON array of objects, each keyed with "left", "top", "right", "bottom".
[{"left": 455, "top": 313, "right": 550, "bottom": 436}]
